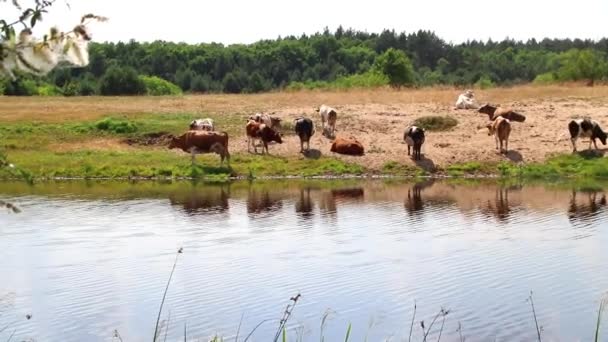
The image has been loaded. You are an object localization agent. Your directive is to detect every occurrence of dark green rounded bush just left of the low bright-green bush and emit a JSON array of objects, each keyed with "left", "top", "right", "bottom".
[{"left": 99, "top": 65, "right": 146, "bottom": 95}]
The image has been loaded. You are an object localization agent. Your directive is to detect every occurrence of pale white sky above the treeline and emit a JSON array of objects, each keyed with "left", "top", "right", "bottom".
[{"left": 0, "top": 0, "right": 608, "bottom": 44}]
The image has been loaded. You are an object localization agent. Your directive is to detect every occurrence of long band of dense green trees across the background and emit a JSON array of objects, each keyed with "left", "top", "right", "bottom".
[{"left": 0, "top": 28, "right": 608, "bottom": 96}]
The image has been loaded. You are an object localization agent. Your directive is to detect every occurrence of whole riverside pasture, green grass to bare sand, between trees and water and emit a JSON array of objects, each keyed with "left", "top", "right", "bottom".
[{"left": 0, "top": 86, "right": 608, "bottom": 180}]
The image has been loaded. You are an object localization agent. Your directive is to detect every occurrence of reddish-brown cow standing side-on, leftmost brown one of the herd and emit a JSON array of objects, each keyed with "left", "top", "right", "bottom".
[{"left": 169, "top": 131, "right": 230, "bottom": 164}]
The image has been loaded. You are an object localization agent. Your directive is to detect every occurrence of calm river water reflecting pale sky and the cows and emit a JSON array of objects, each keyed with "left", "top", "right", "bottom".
[{"left": 0, "top": 181, "right": 608, "bottom": 341}]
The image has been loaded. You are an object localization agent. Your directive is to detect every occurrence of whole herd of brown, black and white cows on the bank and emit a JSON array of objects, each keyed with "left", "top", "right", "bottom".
[{"left": 169, "top": 90, "right": 607, "bottom": 164}]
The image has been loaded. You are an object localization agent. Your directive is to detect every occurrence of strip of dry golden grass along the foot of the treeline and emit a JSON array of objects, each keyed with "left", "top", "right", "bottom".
[{"left": 0, "top": 84, "right": 608, "bottom": 122}]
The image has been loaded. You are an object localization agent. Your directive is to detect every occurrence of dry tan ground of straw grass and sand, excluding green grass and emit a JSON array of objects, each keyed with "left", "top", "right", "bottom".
[{"left": 0, "top": 85, "right": 608, "bottom": 170}]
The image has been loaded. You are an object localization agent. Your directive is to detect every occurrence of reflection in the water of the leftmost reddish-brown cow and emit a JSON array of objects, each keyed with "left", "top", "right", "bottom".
[{"left": 169, "top": 186, "right": 230, "bottom": 215}]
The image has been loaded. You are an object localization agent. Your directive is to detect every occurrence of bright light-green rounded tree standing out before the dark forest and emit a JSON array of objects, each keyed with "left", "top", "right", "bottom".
[{"left": 374, "top": 48, "right": 415, "bottom": 87}]
